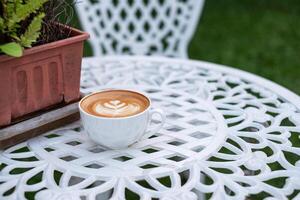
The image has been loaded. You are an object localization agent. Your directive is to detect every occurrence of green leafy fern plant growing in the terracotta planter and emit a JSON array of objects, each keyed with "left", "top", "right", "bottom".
[{"left": 0, "top": 0, "right": 49, "bottom": 57}]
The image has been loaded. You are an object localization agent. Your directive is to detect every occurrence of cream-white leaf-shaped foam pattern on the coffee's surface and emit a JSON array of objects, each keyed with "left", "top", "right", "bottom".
[{"left": 94, "top": 100, "right": 141, "bottom": 117}]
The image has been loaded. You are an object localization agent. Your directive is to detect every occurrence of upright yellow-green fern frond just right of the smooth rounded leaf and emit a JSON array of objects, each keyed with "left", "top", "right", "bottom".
[{"left": 20, "top": 13, "right": 45, "bottom": 47}]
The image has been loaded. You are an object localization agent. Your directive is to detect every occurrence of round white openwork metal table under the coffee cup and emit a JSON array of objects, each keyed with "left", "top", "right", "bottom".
[{"left": 0, "top": 57, "right": 300, "bottom": 200}]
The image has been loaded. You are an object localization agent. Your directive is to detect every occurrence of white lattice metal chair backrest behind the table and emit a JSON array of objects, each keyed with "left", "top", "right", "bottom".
[{"left": 76, "top": 0, "right": 204, "bottom": 57}]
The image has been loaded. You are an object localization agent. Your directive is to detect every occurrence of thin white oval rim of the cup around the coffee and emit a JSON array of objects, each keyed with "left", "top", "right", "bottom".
[{"left": 78, "top": 88, "right": 152, "bottom": 120}]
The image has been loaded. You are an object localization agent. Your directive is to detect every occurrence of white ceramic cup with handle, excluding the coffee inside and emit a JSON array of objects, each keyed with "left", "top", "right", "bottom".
[{"left": 79, "top": 89, "right": 166, "bottom": 149}]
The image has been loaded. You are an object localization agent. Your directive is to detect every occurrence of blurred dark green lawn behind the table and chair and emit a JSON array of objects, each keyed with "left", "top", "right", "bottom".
[{"left": 73, "top": 0, "right": 300, "bottom": 95}]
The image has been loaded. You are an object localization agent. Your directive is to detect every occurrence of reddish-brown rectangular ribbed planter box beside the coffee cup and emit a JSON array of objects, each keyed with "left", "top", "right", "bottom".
[{"left": 0, "top": 24, "right": 89, "bottom": 127}]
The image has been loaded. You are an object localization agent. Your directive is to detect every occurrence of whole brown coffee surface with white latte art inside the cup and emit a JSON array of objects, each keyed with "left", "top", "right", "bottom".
[{"left": 80, "top": 90, "right": 150, "bottom": 118}]
